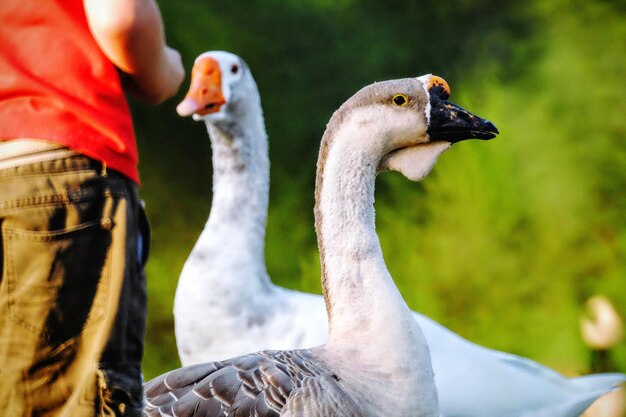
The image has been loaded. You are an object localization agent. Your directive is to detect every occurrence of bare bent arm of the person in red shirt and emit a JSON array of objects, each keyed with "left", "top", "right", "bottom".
[{"left": 84, "top": 0, "right": 185, "bottom": 104}]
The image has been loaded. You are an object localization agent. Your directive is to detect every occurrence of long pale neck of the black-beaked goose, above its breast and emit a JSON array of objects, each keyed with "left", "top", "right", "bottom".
[{"left": 316, "top": 136, "right": 424, "bottom": 346}]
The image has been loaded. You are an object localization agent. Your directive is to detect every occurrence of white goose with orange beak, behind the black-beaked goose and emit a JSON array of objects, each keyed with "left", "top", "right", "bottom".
[{"left": 168, "top": 52, "right": 623, "bottom": 417}]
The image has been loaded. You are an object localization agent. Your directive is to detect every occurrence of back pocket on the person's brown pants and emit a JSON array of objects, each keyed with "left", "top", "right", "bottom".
[{"left": 4, "top": 219, "right": 112, "bottom": 342}]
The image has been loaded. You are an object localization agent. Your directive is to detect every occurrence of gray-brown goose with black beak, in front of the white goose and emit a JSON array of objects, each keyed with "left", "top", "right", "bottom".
[{"left": 152, "top": 63, "right": 497, "bottom": 417}]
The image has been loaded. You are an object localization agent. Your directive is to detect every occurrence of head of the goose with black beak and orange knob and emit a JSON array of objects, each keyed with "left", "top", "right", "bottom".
[{"left": 321, "top": 74, "right": 499, "bottom": 185}]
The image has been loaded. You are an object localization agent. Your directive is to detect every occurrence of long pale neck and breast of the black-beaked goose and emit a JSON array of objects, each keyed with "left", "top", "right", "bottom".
[{"left": 315, "top": 113, "right": 437, "bottom": 415}]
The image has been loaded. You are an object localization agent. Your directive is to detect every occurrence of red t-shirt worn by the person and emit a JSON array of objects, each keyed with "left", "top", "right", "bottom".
[{"left": 0, "top": 0, "right": 139, "bottom": 182}]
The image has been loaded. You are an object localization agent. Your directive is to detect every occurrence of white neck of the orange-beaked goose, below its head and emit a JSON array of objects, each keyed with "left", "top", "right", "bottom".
[{"left": 188, "top": 101, "right": 269, "bottom": 294}]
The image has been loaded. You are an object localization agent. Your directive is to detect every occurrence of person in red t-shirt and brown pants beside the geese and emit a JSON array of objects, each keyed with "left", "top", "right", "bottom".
[{"left": 0, "top": 0, "right": 184, "bottom": 417}]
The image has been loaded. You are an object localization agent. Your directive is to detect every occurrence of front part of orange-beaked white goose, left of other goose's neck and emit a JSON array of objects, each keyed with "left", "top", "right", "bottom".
[{"left": 174, "top": 51, "right": 328, "bottom": 365}]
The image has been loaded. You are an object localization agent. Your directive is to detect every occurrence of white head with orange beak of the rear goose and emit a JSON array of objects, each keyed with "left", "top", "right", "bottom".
[{"left": 176, "top": 51, "right": 260, "bottom": 124}]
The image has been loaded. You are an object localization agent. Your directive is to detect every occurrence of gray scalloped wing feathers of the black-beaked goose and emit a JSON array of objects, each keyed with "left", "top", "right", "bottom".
[{"left": 144, "top": 350, "right": 328, "bottom": 417}]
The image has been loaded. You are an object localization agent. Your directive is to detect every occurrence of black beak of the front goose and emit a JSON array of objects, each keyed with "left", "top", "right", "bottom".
[{"left": 426, "top": 85, "right": 500, "bottom": 143}]
